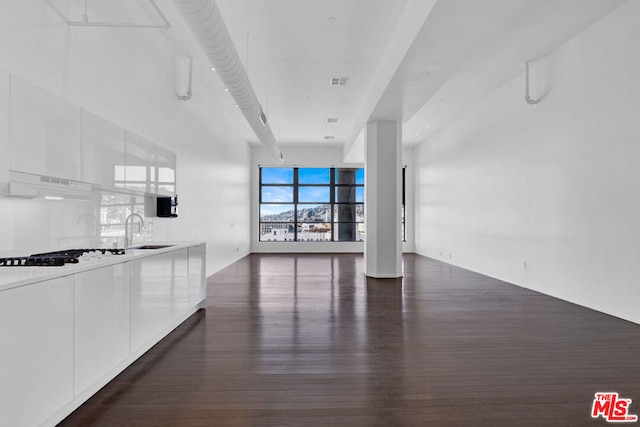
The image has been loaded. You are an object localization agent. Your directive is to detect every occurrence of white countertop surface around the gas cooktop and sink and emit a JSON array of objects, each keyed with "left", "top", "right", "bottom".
[{"left": 0, "top": 242, "right": 204, "bottom": 291}]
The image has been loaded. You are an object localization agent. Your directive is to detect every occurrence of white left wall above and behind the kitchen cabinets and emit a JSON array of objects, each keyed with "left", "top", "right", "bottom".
[{"left": 0, "top": 0, "right": 250, "bottom": 274}]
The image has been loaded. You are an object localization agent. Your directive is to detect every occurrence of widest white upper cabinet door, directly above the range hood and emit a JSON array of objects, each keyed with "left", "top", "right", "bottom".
[{"left": 9, "top": 76, "right": 81, "bottom": 180}]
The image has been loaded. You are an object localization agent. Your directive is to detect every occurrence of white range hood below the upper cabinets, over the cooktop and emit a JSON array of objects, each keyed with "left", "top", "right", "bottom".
[{"left": 2, "top": 170, "right": 100, "bottom": 200}]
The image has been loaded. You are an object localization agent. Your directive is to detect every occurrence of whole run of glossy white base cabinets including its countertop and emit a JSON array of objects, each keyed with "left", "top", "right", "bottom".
[{"left": 0, "top": 242, "right": 206, "bottom": 426}]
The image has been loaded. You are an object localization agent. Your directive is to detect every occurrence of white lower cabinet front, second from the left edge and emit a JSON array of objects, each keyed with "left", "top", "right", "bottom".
[{"left": 73, "top": 263, "right": 130, "bottom": 395}]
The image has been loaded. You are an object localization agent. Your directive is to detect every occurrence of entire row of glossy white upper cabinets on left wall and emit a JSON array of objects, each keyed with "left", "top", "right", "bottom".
[{"left": 0, "top": 74, "right": 176, "bottom": 199}]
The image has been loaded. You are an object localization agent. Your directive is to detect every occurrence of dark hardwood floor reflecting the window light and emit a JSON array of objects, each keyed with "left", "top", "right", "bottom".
[{"left": 60, "top": 254, "right": 640, "bottom": 427}]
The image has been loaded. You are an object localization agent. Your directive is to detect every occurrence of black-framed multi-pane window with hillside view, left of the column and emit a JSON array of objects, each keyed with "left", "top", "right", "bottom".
[{"left": 260, "top": 168, "right": 364, "bottom": 242}]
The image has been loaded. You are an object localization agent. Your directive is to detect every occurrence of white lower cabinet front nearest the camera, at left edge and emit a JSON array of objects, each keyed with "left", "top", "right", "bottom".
[{"left": 0, "top": 276, "right": 73, "bottom": 427}]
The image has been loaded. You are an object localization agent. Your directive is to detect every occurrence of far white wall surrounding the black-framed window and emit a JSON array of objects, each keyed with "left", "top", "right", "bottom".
[{"left": 251, "top": 145, "right": 414, "bottom": 253}]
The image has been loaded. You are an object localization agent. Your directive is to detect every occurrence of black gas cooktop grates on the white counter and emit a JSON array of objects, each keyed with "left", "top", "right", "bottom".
[{"left": 0, "top": 249, "right": 125, "bottom": 267}]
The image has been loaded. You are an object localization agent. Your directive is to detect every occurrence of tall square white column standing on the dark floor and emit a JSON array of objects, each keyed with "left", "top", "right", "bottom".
[{"left": 364, "top": 121, "right": 402, "bottom": 278}]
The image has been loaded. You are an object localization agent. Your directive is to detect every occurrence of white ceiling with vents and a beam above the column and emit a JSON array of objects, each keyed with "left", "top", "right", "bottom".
[{"left": 71, "top": 0, "right": 627, "bottom": 161}]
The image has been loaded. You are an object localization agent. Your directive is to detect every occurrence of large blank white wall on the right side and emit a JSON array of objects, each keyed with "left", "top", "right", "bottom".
[{"left": 416, "top": 2, "right": 640, "bottom": 323}]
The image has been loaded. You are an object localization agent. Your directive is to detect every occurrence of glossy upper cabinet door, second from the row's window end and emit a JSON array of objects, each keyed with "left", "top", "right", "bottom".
[{"left": 124, "top": 131, "right": 156, "bottom": 193}]
